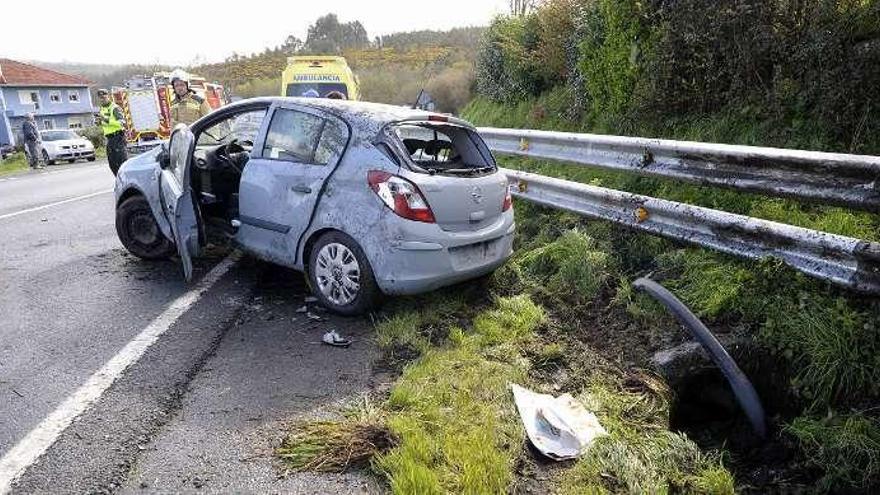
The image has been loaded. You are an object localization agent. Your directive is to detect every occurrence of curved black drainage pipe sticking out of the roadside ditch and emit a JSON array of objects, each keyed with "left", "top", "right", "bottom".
[{"left": 633, "top": 278, "right": 767, "bottom": 439}]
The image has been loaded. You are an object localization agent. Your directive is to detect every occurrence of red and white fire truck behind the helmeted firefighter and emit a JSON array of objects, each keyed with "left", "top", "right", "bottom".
[{"left": 111, "top": 72, "right": 228, "bottom": 154}]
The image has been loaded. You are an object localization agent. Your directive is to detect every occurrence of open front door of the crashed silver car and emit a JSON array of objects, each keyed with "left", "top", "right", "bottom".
[{"left": 160, "top": 124, "right": 201, "bottom": 282}]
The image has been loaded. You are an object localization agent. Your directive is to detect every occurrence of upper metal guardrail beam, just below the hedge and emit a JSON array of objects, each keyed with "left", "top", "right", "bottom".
[{"left": 478, "top": 127, "right": 880, "bottom": 212}]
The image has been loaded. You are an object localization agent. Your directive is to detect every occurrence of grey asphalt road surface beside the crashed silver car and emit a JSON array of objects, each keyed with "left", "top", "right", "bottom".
[{"left": 0, "top": 163, "right": 379, "bottom": 493}]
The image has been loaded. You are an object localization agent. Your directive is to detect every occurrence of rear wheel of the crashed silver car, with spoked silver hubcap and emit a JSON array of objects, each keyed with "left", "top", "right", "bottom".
[{"left": 308, "top": 232, "right": 381, "bottom": 315}]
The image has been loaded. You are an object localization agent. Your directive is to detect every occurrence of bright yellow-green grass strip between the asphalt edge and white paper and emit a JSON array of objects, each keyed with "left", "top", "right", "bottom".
[{"left": 376, "top": 297, "right": 545, "bottom": 493}]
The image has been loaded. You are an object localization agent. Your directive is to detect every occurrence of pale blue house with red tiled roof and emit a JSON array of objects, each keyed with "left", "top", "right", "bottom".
[{"left": 0, "top": 58, "right": 97, "bottom": 146}]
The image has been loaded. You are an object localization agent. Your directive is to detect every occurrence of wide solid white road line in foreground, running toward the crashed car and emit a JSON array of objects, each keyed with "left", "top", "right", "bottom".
[{"left": 0, "top": 252, "right": 240, "bottom": 495}]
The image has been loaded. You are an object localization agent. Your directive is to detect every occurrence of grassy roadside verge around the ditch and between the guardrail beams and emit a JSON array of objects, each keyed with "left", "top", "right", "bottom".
[{"left": 285, "top": 92, "right": 880, "bottom": 493}]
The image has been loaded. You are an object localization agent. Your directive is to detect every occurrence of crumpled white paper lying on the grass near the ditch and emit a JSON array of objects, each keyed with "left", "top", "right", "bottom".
[{"left": 510, "top": 383, "right": 608, "bottom": 461}]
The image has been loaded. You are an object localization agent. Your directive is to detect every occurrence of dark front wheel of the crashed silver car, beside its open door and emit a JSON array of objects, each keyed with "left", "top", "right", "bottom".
[{"left": 116, "top": 196, "right": 175, "bottom": 260}]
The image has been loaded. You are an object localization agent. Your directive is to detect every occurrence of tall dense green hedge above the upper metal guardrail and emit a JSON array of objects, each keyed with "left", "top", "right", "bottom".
[{"left": 476, "top": 0, "right": 880, "bottom": 152}]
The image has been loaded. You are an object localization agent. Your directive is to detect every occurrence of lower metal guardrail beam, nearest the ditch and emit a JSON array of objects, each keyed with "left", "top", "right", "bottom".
[{"left": 501, "top": 169, "right": 880, "bottom": 294}]
